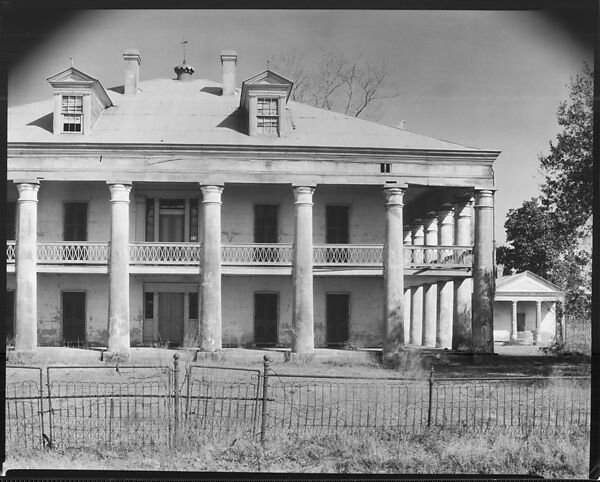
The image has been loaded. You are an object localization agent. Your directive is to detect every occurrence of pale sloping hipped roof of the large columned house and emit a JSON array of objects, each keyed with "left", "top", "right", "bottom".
[{"left": 8, "top": 79, "right": 479, "bottom": 152}]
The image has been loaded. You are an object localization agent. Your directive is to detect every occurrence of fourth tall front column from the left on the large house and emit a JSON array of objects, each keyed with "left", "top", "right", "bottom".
[{"left": 292, "top": 186, "right": 315, "bottom": 353}]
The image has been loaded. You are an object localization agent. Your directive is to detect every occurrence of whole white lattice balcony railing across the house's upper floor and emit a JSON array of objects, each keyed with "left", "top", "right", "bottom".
[{"left": 6, "top": 241, "right": 473, "bottom": 270}]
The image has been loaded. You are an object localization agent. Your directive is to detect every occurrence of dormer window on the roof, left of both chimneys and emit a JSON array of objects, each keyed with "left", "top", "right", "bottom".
[{"left": 48, "top": 67, "right": 112, "bottom": 135}]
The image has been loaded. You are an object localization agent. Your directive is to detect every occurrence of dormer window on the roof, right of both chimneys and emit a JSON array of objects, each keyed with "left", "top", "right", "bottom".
[{"left": 240, "top": 70, "right": 293, "bottom": 137}]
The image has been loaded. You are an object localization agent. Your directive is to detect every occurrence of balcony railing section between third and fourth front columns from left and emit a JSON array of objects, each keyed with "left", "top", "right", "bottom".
[{"left": 221, "top": 244, "right": 292, "bottom": 266}]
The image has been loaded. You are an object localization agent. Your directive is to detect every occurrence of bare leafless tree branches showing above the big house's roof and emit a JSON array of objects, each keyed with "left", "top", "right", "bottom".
[{"left": 272, "top": 50, "right": 399, "bottom": 119}]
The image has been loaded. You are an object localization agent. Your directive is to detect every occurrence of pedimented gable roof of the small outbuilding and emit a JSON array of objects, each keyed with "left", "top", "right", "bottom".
[{"left": 494, "top": 271, "right": 565, "bottom": 301}]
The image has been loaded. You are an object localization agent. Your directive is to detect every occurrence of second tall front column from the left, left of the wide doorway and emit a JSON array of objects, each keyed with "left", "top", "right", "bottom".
[{"left": 107, "top": 183, "right": 131, "bottom": 360}]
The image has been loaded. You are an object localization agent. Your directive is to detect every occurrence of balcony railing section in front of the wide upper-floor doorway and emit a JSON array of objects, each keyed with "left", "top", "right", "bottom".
[{"left": 129, "top": 243, "right": 201, "bottom": 265}]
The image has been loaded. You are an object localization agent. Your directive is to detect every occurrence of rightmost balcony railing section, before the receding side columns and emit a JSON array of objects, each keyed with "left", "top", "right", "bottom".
[{"left": 404, "top": 245, "right": 473, "bottom": 268}]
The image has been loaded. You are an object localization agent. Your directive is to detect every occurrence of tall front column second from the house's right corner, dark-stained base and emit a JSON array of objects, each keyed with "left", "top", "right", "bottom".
[{"left": 383, "top": 187, "right": 404, "bottom": 355}]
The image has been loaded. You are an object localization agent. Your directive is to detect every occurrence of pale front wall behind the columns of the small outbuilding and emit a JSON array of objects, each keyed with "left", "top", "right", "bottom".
[{"left": 494, "top": 301, "right": 556, "bottom": 344}]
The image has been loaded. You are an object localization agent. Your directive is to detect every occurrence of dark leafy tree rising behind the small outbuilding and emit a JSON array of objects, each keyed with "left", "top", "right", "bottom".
[{"left": 497, "top": 64, "right": 593, "bottom": 316}]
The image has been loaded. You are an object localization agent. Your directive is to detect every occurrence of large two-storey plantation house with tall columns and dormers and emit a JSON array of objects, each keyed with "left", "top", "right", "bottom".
[{"left": 7, "top": 49, "right": 499, "bottom": 356}]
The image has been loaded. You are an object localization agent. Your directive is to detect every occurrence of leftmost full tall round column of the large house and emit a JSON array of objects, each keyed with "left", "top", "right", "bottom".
[{"left": 15, "top": 181, "right": 40, "bottom": 351}]
